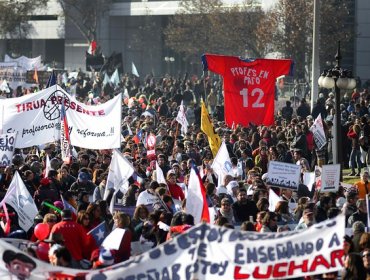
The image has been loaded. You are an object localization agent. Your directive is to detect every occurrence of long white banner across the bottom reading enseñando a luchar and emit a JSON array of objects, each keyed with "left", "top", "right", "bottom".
[{"left": 0, "top": 215, "right": 345, "bottom": 280}]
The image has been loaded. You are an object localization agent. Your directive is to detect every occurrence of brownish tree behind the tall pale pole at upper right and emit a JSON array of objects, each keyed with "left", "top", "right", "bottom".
[{"left": 271, "top": 0, "right": 351, "bottom": 78}]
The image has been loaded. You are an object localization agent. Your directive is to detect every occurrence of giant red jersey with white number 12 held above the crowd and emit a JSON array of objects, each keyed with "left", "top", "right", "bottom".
[{"left": 202, "top": 54, "right": 293, "bottom": 127}]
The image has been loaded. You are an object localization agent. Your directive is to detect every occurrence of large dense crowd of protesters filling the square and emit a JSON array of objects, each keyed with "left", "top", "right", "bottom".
[{"left": 0, "top": 70, "right": 370, "bottom": 279}]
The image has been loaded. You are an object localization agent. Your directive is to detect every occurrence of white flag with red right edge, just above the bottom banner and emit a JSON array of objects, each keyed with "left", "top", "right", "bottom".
[{"left": 186, "top": 167, "right": 210, "bottom": 224}]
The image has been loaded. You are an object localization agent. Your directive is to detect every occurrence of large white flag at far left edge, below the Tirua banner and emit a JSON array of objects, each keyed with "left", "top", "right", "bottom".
[{"left": 0, "top": 171, "right": 38, "bottom": 231}]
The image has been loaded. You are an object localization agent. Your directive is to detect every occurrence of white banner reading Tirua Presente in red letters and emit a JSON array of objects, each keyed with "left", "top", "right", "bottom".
[{"left": 0, "top": 86, "right": 121, "bottom": 149}]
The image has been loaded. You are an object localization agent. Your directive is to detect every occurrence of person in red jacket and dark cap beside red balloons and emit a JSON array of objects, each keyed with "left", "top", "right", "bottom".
[{"left": 51, "top": 210, "right": 86, "bottom": 261}]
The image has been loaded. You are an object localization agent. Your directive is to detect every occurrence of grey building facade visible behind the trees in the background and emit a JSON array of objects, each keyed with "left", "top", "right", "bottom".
[{"left": 0, "top": 0, "right": 370, "bottom": 86}]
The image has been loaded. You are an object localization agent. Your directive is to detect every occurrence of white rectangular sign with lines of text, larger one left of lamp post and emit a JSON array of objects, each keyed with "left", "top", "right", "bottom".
[{"left": 267, "top": 161, "right": 301, "bottom": 190}]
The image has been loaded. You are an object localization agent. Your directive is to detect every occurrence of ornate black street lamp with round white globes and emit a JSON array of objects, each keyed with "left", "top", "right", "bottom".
[{"left": 318, "top": 41, "right": 356, "bottom": 179}]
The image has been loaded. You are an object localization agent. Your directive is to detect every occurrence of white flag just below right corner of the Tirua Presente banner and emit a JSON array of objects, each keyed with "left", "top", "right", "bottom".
[{"left": 104, "top": 149, "right": 134, "bottom": 199}]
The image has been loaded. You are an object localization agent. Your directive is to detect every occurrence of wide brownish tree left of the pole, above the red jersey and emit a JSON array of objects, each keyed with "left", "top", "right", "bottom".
[{"left": 164, "top": 0, "right": 276, "bottom": 63}]
